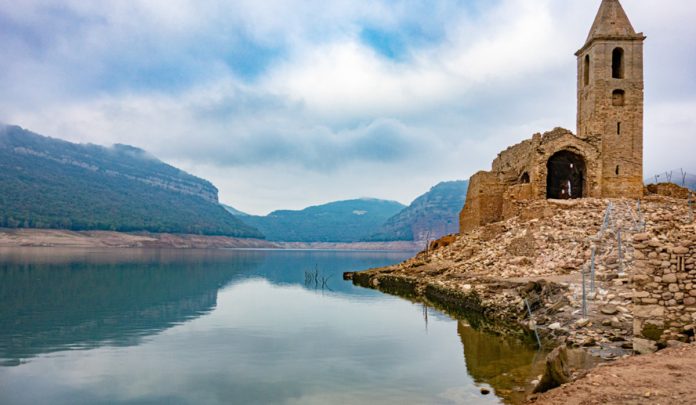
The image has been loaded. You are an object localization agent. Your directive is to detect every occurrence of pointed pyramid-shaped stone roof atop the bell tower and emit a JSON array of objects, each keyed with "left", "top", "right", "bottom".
[{"left": 583, "top": 0, "right": 645, "bottom": 54}]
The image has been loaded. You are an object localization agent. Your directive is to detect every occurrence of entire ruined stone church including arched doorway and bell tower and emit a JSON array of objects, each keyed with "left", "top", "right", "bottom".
[{"left": 460, "top": 0, "right": 645, "bottom": 233}]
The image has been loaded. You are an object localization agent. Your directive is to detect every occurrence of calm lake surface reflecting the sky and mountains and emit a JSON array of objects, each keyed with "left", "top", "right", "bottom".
[{"left": 0, "top": 248, "right": 539, "bottom": 404}]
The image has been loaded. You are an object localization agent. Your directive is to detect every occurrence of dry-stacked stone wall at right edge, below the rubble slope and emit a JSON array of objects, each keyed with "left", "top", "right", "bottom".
[{"left": 631, "top": 223, "right": 696, "bottom": 342}]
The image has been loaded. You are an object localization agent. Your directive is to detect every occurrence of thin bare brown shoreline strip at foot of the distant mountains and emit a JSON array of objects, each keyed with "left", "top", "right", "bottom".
[{"left": 0, "top": 228, "right": 424, "bottom": 251}]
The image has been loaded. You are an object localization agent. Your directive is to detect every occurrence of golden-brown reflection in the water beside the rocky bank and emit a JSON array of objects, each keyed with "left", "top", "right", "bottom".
[{"left": 457, "top": 322, "right": 545, "bottom": 402}]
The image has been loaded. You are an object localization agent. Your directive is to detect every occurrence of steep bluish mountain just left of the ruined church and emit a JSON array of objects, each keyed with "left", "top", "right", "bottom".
[{"left": 368, "top": 180, "right": 469, "bottom": 241}]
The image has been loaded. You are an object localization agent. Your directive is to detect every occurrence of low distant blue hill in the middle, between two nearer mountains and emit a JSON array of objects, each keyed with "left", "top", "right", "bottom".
[{"left": 245, "top": 199, "right": 405, "bottom": 242}]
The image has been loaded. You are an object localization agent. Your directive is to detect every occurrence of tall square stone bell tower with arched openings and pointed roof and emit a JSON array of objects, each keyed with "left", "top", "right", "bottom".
[{"left": 575, "top": 0, "right": 646, "bottom": 198}]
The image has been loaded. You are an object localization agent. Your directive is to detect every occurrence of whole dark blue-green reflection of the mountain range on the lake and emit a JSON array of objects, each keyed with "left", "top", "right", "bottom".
[{"left": 0, "top": 248, "right": 410, "bottom": 365}]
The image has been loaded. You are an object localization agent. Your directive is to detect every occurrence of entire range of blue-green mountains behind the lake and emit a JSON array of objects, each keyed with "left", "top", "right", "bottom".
[{"left": 0, "top": 125, "right": 467, "bottom": 243}]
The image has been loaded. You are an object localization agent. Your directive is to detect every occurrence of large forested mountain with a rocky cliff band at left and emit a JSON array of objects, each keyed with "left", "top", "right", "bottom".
[{"left": 0, "top": 126, "right": 262, "bottom": 238}]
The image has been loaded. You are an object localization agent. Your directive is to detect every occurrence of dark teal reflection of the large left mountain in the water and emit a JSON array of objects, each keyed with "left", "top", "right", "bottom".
[{"left": 0, "top": 250, "right": 263, "bottom": 363}]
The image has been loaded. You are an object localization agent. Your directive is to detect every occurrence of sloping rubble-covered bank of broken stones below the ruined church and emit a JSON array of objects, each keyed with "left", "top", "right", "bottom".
[{"left": 348, "top": 196, "right": 693, "bottom": 398}]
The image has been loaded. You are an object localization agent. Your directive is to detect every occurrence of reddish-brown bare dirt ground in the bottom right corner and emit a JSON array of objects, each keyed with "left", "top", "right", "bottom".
[{"left": 530, "top": 345, "right": 696, "bottom": 405}]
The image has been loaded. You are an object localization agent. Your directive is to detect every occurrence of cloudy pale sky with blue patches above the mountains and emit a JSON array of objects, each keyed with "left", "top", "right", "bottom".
[{"left": 0, "top": 0, "right": 696, "bottom": 214}]
